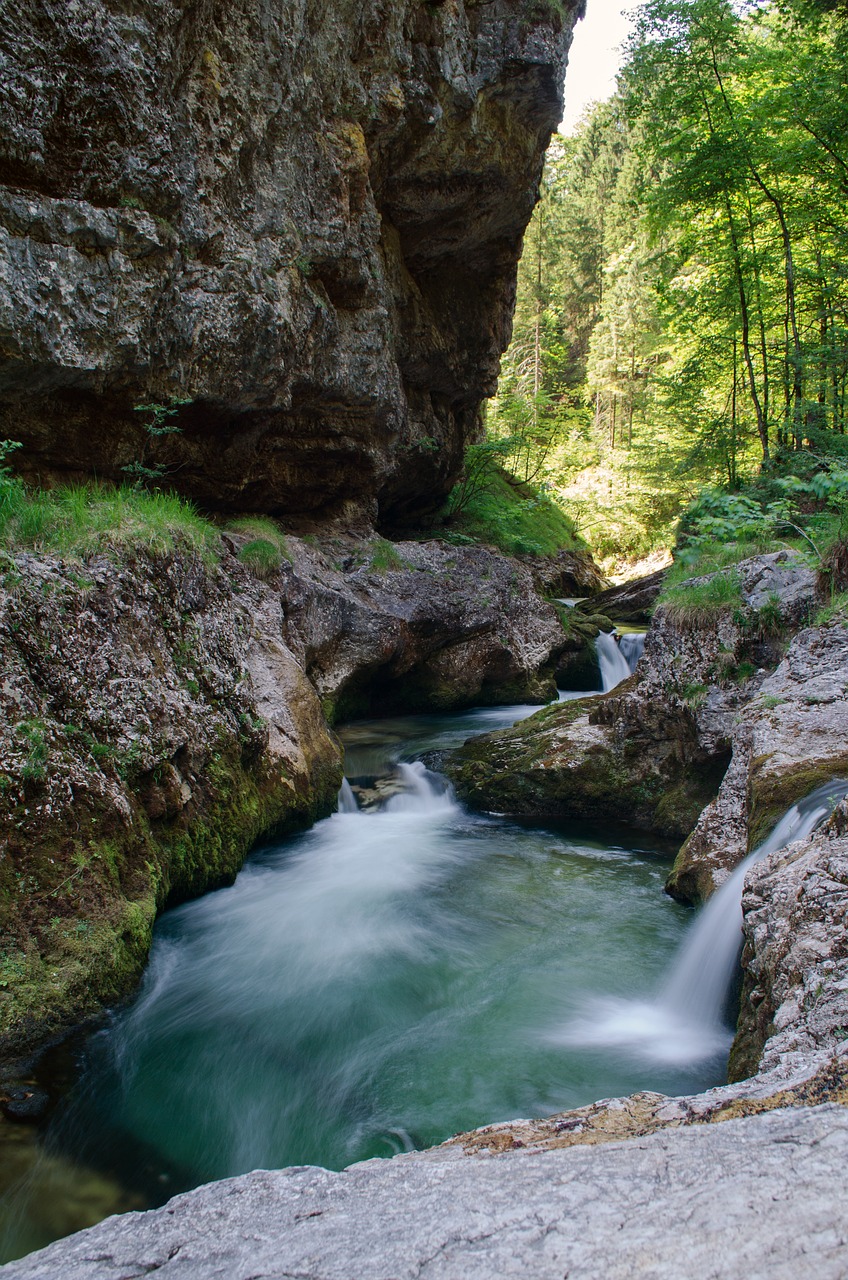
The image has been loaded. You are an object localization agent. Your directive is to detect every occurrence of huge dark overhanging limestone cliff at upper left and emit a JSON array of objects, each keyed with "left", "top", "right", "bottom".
[{"left": 0, "top": 0, "right": 579, "bottom": 524}]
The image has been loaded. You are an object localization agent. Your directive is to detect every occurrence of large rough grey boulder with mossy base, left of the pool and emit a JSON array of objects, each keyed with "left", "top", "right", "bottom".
[{"left": 0, "top": 535, "right": 341, "bottom": 1052}]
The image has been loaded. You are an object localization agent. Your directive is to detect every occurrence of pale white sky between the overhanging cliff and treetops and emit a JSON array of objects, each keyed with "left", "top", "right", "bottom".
[{"left": 560, "top": 0, "right": 635, "bottom": 133}]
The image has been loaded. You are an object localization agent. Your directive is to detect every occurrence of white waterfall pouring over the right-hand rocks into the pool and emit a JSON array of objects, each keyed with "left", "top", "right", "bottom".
[{"left": 559, "top": 780, "right": 848, "bottom": 1064}]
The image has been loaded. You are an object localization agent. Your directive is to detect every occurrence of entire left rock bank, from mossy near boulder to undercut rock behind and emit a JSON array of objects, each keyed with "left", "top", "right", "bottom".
[{"left": 0, "top": 524, "right": 581, "bottom": 1055}]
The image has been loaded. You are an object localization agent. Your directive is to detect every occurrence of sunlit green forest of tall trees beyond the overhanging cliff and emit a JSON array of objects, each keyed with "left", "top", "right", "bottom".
[{"left": 471, "top": 0, "right": 848, "bottom": 567}]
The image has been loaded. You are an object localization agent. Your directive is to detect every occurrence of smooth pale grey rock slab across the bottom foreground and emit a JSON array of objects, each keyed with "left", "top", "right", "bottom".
[{"left": 0, "top": 1105, "right": 848, "bottom": 1280}]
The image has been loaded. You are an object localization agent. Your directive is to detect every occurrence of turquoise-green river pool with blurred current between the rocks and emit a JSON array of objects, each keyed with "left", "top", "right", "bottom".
[{"left": 0, "top": 680, "right": 728, "bottom": 1257}]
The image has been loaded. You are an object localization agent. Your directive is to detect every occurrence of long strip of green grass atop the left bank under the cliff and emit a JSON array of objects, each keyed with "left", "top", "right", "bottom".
[{"left": 0, "top": 468, "right": 219, "bottom": 559}]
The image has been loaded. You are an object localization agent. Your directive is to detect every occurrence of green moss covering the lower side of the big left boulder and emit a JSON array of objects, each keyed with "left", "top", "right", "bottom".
[{"left": 0, "top": 739, "right": 341, "bottom": 1052}]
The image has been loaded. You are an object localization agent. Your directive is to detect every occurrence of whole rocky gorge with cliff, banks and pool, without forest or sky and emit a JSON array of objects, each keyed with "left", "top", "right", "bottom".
[{"left": 0, "top": 0, "right": 848, "bottom": 1280}]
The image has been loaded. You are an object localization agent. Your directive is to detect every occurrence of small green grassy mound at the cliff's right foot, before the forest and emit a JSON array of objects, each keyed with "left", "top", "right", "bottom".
[{"left": 446, "top": 470, "right": 585, "bottom": 556}]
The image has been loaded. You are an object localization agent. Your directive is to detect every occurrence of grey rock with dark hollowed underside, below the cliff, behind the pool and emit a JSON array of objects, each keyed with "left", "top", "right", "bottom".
[{"left": 275, "top": 538, "right": 567, "bottom": 719}]
